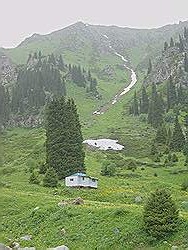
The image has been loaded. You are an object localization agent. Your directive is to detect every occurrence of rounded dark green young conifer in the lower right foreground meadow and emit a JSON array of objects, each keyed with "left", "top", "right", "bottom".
[{"left": 143, "top": 189, "right": 179, "bottom": 239}]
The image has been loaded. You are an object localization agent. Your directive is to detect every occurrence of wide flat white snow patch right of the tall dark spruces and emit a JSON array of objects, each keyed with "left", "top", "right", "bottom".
[{"left": 83, "top": 139, "right": 124, "bottom": 150}]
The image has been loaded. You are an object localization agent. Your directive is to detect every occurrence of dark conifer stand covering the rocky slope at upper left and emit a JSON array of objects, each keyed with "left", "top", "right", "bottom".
[{"left": 0, "top": 51, "right": 100, "bottom": 124}]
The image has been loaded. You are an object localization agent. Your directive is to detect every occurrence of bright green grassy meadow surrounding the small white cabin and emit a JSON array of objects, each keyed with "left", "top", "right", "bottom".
[{"left": 0, "top": 69, "right": 188, "bottom": 250}]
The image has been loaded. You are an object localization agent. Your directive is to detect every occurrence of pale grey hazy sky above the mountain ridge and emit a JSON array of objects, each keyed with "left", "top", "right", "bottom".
[{"left": 0, "top": 0, "right": 188, "bottom": 47}]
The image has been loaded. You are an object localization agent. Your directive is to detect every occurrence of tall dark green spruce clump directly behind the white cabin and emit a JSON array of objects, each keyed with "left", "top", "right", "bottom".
[{"left": 46, "top": 97, "right": 85, "bottom": 179}]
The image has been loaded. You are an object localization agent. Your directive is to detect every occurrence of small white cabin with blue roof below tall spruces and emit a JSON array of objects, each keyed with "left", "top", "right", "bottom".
[{"left": 65, "top": 173, "right": 98, "bottom": 188}]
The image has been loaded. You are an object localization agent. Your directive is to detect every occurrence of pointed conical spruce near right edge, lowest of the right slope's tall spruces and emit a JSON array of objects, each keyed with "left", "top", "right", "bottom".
[{"left": 170, "top": 116, "right": 185, "bottom": 151}]
